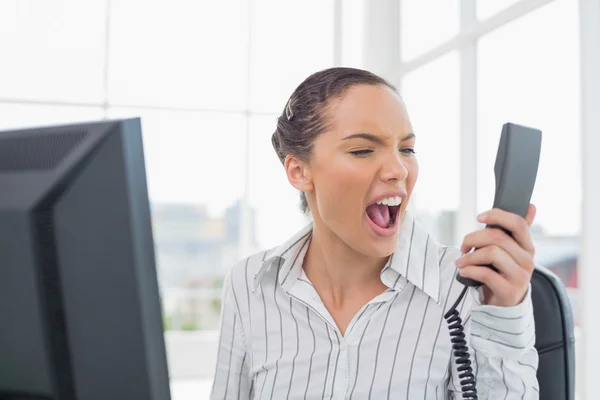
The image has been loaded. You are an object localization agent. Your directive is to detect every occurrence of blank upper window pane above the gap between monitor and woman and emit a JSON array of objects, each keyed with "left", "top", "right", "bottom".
[{"left": 109, "top": 0, "right": 248, "bottom": 110}]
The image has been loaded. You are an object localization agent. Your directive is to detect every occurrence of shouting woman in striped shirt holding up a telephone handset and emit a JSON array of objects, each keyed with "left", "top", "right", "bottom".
[{"left": 212, "top": 68, "right": 539, "bottom": 400}]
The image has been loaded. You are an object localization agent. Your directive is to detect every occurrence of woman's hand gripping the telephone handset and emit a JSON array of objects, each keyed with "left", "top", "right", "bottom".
[{"left": 456, "top": 204, "right": 536, "bottom": 307}]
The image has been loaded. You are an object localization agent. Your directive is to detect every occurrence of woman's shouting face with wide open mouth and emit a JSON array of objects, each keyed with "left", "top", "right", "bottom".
[{"left": 306, "top": 85, "right": 419, "bottom": 257}]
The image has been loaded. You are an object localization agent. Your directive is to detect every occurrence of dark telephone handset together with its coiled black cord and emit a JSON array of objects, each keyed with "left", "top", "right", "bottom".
[{"left": 444, "top": 123, "right": 542, "bottom": 399}]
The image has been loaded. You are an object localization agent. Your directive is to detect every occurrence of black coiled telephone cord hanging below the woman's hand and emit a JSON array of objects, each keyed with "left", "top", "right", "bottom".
[{"left": 444, "top": 286, "right": 477, "bottom": 400}]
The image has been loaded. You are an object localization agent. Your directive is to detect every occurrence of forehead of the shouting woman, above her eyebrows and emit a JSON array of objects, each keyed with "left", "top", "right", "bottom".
[{"left": 328, "top": 85, "right": 413, "bottom": 136}]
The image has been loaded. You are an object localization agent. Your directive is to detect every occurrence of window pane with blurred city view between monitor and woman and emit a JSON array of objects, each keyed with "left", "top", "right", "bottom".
[{"left": 109, "top": 108, "right": 246, "bottom": 330}]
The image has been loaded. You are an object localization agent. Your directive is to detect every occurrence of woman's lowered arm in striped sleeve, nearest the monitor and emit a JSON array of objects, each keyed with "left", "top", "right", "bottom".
[{"left": 210, "top": 276, "right": 252, "bottom": 400}]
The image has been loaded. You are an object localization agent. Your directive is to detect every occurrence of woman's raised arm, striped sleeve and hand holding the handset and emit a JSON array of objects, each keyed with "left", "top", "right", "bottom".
[{"left": 455, "top": 205, "right": 539, "bottom": 400}]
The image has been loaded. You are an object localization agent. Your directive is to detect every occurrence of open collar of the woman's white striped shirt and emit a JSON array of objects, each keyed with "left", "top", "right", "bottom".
[{"left": 254, "top": 212, "right": 442, "bottom": 303}]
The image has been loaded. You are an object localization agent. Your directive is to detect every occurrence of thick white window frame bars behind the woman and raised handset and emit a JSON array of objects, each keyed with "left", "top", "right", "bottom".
[{"left": 356, "top": 0, "right": 600, "bottom": 399}]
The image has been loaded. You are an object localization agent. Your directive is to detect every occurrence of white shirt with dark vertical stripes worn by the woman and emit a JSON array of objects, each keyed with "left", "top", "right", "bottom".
[{"left": 211, "top": 213, "right": 539, "bottom": 400}]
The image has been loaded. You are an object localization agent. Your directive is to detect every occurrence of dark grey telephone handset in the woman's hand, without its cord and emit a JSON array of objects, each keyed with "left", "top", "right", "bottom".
[{"left": 457, "top": 123, "right": 542, "bottom": 287}]
